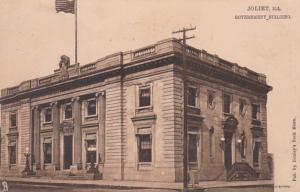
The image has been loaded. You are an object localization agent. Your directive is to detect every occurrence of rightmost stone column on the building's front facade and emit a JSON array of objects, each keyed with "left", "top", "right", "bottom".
[{"left": 96, "top": 92, "right": 105, "bottom": 164}]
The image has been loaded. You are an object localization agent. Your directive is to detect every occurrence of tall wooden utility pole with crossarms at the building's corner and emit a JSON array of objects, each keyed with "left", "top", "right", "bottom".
[{"left": 172, "top": 27, "right": 196, "bottom": 191}]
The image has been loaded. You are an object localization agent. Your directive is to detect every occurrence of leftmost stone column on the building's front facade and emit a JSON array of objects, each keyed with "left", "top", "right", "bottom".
[{"left": 33, "top": 106, "right": 41, "bottom": 170}]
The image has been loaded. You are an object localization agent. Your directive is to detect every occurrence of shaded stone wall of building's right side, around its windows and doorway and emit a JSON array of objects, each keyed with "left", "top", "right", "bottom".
[{"left": 182, "top": 65, "right": 268, "bottom": 180}]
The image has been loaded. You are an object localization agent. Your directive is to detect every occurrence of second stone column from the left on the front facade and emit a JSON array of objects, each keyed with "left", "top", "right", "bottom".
[{"left": 51, "top": 102, "right": 60, "bottom": 170}]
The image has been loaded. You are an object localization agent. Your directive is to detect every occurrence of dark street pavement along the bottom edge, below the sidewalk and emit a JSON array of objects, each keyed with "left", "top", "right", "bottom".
[{"left": 4, "top": 183, "right": 274, "bottom": 192}]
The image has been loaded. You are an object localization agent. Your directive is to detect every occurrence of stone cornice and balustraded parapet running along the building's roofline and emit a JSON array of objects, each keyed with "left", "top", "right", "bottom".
[{"left": 0, "top": 39, "right": 272, "bottom": 103}]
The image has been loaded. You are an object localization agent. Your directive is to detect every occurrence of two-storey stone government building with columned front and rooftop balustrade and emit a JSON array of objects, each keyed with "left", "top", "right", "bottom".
[{"left": 0, "top": 39, "right": 272, "bottom": 182}]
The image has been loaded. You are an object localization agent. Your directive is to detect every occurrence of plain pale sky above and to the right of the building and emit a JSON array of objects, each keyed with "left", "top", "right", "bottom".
[{"left": 0, "top": 0, "right": 300, "bottom": 191}]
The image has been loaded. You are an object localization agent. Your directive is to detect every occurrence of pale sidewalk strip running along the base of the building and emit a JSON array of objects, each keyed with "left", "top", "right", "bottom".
[{"left": 0, "top": 177, "right": 273, "bottom": 191}]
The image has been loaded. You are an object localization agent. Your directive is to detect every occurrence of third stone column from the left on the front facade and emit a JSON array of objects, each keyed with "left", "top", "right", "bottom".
[{"left": 73, "top": 97, "right": 82, "bottom": 170}]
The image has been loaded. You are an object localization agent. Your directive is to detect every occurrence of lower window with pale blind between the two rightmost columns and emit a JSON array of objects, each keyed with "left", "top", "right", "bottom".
[{"left": 85, "top": 133, "right": 97, "bottom": 163}]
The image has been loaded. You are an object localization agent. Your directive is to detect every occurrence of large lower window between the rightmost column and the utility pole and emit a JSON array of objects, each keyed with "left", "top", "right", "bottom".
[{"left": 138, "top": 134, "right": 152, "bottom": 162}]
